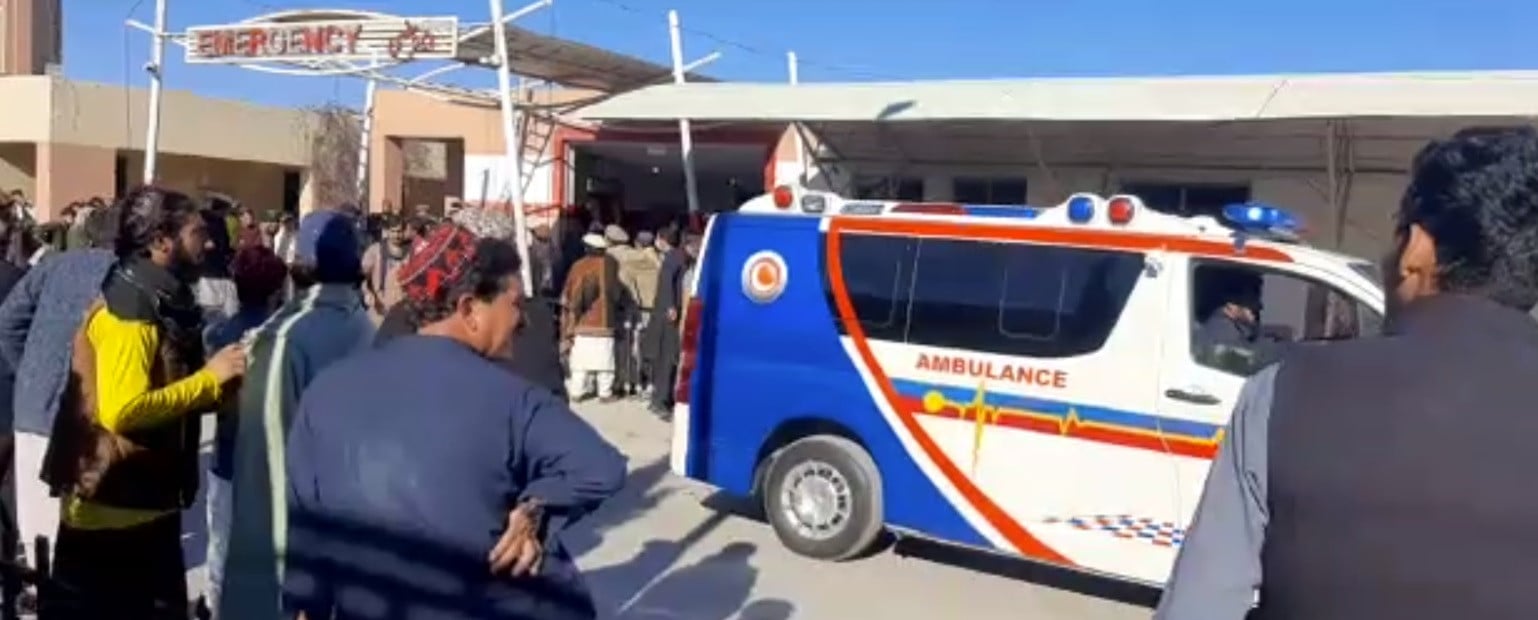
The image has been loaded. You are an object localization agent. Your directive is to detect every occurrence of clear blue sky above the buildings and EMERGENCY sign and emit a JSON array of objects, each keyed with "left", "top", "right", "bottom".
[{"left": 65, "top": 0, "right": 1538, "bottom": 106}]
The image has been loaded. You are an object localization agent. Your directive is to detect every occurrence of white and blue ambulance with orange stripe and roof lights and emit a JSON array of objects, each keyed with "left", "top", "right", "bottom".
[{"left": 671, "top": 186, "right": 1383, "bottom": 585}]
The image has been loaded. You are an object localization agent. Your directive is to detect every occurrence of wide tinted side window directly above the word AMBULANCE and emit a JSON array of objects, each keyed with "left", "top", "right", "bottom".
[{"left": 906, "top": 238, "right": 1143, "bottom": 357}]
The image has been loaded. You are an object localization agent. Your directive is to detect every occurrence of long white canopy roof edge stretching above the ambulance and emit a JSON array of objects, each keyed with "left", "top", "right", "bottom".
[{"left": 580, "top": 72, "right": 1538, "bottom": 123}]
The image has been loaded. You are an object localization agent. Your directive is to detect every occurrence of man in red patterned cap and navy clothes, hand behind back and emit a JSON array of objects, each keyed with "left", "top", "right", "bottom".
[{"left": 286, "top": 223, "right": 624, "bottom": 620}]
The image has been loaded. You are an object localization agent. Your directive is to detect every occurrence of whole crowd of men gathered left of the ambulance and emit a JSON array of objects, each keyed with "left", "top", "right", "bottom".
[{"left": 0, "top": 186, "right": 698, "bottom": 620}]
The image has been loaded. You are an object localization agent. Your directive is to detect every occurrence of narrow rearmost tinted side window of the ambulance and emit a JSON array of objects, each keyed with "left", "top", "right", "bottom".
[{"left": 838, "top": 235, "right": 917, "bottom": 342}]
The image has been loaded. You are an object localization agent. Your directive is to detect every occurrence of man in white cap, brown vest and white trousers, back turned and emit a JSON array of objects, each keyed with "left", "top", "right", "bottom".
[{"left": 561, "top": 234, "right": 628, "bottom": 402}]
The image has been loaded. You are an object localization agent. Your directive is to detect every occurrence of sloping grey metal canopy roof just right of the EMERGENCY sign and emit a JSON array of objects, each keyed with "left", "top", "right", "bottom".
[{"left": 458, "top": 25, "right": 715, "bottom": 92}]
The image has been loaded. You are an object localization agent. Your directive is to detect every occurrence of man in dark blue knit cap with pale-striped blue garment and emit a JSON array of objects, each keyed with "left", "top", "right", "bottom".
[{"left": 218, "top": 211, "right": 374, "bottom": 620}]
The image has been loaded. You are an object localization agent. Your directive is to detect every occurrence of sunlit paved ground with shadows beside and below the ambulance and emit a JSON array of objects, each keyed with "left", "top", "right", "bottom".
[{"left": 571, "top": 403, "right": 1152, "bottom": 620}]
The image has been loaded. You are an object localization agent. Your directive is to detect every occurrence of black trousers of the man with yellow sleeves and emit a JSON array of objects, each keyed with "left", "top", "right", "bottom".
[{"left": 38, "top": 514, "right": 188, "bottom": 620}]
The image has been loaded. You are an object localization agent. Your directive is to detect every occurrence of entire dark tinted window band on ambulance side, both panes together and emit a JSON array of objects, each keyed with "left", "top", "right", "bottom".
[{"left": 840, "top": 235, "right": 1143, "bottom": 357}]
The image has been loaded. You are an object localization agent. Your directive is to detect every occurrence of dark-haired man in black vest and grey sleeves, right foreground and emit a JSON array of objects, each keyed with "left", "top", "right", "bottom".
[{"left": 1155, "top": 128, "right": 1538, "bottom": 620}]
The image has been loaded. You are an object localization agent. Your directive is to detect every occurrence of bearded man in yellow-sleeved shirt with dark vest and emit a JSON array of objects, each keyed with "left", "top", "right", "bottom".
[{"left": 40, "top": 188, "right": 245, "bottom": 620}]
